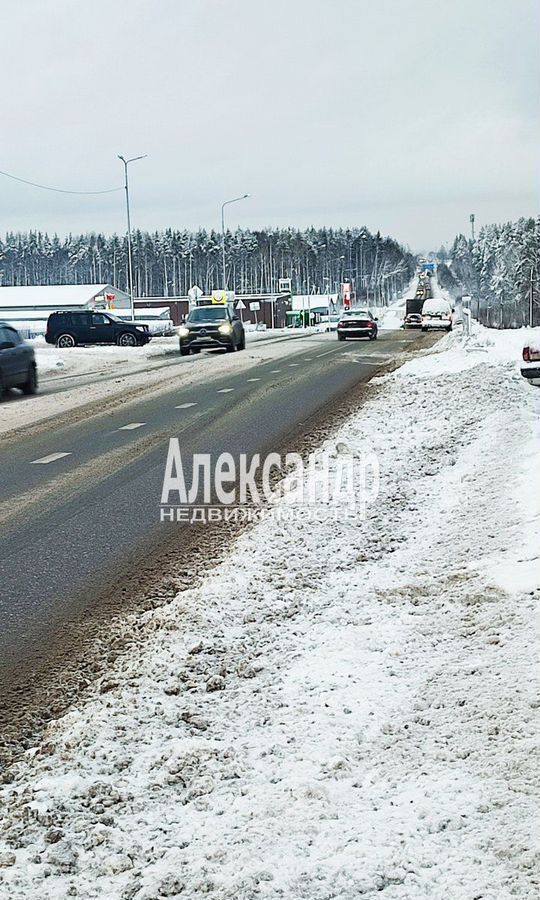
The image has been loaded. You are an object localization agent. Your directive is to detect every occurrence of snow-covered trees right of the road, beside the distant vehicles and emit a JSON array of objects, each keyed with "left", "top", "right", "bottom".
[{"left": 437, "top": 216, "right": 540, "bottom": 328}]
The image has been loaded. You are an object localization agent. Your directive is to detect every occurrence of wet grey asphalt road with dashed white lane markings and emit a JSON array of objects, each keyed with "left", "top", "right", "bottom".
[{"left": 0, "top": 331, "right": 433, "bottom": 675}]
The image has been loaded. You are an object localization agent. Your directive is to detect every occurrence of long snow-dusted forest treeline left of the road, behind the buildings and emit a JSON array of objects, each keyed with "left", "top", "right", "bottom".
[{"left": 0, "top": 228, "right": 415, "bottom": 302}]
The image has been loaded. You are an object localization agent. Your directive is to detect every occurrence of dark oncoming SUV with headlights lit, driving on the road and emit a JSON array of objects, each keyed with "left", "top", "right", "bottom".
[{"left": 178, "top": 304, "right": 246, "bottom": 356}]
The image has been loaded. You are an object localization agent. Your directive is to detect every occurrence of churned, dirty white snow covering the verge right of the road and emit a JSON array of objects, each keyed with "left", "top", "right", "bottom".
[{"left": 0, "top": 329, "right": 540, "bottom": 900}]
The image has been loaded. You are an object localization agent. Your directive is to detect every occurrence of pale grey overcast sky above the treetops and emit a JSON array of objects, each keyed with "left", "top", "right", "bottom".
[{"left": 0, "top": 0, "right": 540, "bottom": 250}]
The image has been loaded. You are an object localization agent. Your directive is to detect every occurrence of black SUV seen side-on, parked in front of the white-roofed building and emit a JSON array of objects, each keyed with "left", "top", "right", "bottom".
[{"left": 45, "top": 309, "right": 150, "bottom": 347}]
